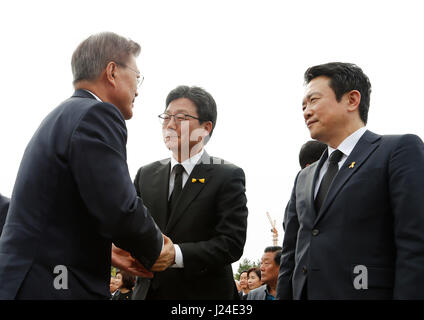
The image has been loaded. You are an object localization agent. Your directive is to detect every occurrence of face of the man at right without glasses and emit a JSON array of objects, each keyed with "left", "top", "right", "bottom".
[{"left": 302, "top": 76, "right": 348, "bottom": 144}]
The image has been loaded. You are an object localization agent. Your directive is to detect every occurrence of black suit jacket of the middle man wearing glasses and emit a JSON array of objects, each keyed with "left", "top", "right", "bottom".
[{"left": 134, "top": 152, "right": 248, "bottom": 300}]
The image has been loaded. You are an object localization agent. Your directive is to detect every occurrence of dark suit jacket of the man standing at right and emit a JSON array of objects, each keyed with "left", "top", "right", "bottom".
[{"left": 277, "top": 131, "right": 424, "bottom": 299}]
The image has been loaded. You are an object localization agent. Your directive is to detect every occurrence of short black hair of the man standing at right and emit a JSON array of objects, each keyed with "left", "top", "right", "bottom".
[{"left": 304, "top": 62, "right": 371, "bottom": 124}]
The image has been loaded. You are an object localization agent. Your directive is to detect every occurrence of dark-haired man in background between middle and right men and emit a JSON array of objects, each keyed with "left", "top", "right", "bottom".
[{"left": 247, "top": 246, "right": 281, "bottom": 300}]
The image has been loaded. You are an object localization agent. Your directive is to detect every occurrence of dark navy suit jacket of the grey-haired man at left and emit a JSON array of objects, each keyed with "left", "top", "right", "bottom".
[{"left": 0, "top": 90, "right": 162, "bottom": 299}]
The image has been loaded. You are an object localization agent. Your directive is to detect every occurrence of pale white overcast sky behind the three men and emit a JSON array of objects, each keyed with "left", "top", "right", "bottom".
[{"left": 0, "top": 0, "right": 424, "bottom": 270}]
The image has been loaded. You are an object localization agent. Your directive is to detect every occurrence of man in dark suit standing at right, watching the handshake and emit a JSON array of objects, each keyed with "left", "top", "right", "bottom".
[{"left": 277, "top": 63, "right": 424, "bottom": 299}]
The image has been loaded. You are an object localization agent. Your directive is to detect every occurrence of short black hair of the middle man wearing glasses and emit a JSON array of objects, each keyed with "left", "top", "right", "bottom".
[{"left": 165, "top": 86, "right": 217, "bottom": 144}]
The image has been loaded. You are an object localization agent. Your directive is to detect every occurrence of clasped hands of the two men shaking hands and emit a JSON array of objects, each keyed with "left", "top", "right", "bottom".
[{"left": 112, "top": 234, "right": 175, "bottom": 278}]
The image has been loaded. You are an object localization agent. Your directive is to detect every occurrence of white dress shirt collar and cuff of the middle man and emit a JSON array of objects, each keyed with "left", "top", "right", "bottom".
[{"left": 168, "top": 149, "right": 205, "bottom": 268}]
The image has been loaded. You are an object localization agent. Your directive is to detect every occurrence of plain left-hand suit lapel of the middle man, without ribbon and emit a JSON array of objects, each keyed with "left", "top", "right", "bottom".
[{"left": 151, "top": 159, "right": 171, "bottom": 230}]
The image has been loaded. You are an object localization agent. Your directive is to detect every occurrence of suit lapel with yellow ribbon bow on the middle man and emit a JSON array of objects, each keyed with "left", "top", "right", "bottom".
[{"left": 165, "top": 151, "right": 213, "bottom": 234}]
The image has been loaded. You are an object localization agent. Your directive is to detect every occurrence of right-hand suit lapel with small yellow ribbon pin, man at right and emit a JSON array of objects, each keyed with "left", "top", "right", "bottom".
[{"left": 315, "top": 130, "right": 381, "bottom": 225}]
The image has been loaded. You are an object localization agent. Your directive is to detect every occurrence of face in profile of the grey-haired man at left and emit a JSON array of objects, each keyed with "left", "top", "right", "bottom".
[{"left": 113, "top": 55, "right": 140, "bottom": 120}]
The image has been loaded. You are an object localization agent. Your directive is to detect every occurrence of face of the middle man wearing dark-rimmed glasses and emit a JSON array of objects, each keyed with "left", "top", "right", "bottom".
[{"left": 162, "top": 98, "right": 208, "bottom": 159}]
